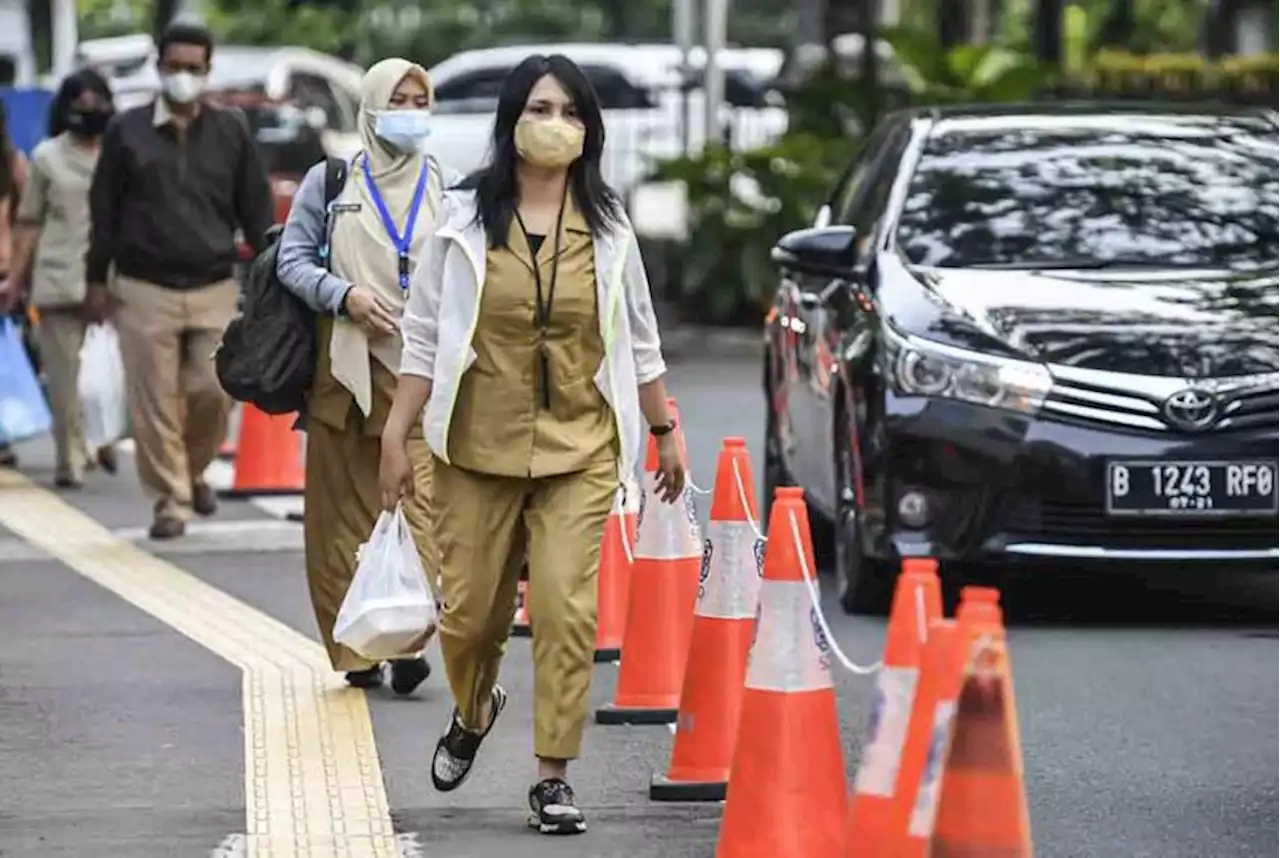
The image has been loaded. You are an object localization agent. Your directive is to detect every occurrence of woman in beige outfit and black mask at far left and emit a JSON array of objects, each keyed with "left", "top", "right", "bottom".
[{"left": 4, "top": 69, "right": 116, "bottom": 488}]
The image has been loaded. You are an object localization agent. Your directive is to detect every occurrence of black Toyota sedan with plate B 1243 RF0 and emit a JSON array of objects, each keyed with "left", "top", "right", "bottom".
[{"left": 764, "top": 104, "right": 1280, "bottom": 611}]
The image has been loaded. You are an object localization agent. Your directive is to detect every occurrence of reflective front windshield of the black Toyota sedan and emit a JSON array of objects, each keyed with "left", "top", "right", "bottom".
[{"left": 897, "top": 115, "right": 1280, "bottom": 269}]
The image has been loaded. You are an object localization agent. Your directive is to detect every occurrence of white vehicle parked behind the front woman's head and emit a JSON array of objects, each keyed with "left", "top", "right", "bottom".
[{"left": 428, "top": 44, "right": 787, "bottom": 208}]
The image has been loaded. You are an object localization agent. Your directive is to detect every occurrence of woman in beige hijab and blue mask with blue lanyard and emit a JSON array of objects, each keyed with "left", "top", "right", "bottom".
[{"left": 276, "top": 59, "right": 460, "bottom": 694}]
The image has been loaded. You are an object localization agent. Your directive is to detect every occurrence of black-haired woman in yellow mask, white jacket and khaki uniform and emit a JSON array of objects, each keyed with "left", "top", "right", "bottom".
[{"left": 381, "top": 56, "right": 685, "bottom": 834}]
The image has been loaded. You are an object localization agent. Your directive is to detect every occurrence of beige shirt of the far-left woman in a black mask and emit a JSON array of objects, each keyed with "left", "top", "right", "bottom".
[{"left": 17, "top": 134, "right": 97, "bottom": 307}]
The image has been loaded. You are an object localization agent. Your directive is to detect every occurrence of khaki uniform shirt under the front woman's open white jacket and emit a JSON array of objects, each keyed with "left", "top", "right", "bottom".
[{"left": 448, "top": 198, "right": 617, "bottom": 478}]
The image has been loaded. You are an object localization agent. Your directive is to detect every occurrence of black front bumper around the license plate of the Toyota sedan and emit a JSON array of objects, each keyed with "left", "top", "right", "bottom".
[{"left": 864, "top": 396, "right": 1280, "bottom": 571}]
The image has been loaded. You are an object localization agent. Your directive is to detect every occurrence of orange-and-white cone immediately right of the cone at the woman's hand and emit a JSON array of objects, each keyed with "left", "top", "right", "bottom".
[{"left": 649, "top": 438, "right": 764, "bottom": 802}]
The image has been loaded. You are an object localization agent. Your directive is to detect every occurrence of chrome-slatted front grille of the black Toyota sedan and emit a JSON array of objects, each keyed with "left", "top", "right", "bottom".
[{"left": 1044, "top": 371, "right": 1280, "bottom": 433}]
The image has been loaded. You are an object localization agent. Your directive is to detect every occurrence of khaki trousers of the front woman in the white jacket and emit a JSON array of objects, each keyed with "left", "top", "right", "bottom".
[{"left": 433, "top": 460, "right": 618, "bottom": 759}]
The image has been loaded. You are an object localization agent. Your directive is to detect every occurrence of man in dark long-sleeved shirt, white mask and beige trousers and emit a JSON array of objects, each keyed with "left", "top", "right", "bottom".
[{"left": 86, "top": 24, "right": 274, "bottom": 539}]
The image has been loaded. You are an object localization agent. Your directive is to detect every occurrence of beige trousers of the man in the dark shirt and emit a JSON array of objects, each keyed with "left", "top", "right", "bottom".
[{"left": 115, "top": 277, "right": 239, "bottom": 521}]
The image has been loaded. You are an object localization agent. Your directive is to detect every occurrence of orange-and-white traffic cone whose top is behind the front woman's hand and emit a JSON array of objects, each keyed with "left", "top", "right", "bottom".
[{"left": 595, "top": 402, "right": 703, "bottom": 725}]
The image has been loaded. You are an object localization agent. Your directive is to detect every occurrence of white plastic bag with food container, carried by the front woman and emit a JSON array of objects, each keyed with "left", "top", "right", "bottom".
[{"left": 333, "top": 506, "right": 436, "bottom": 661}]
